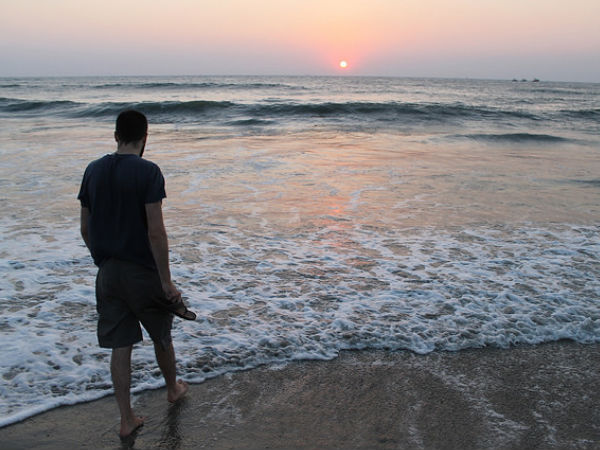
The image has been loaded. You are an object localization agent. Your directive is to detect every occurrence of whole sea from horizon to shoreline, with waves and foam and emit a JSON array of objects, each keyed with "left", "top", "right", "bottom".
[{"left": 0, "top": 77, "right": 600, "bottom": 426}]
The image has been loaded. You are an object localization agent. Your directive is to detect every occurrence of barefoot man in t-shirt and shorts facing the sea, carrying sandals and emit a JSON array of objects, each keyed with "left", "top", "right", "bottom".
[{"left": 78, "top": 110, "right": 196, "bottom": 438}]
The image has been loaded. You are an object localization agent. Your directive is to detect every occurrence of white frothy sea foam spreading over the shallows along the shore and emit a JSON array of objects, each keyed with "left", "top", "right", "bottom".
[{"left": 0, "top": 221, "right": 600, "bottom": 425}]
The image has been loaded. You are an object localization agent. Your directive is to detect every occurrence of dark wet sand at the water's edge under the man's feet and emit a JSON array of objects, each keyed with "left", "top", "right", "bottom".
[{"left": 0, "top": 342, "right": 600, "bottom": 450}]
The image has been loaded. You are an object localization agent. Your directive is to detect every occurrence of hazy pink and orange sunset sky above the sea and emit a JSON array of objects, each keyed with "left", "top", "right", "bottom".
[{"left": 0, "top": 0, "right": 600, "bottom": 82}]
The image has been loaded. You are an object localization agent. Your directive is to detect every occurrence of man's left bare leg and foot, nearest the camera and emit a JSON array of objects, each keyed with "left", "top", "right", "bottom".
[{"left": 110, "top": 345, "right": 144, "bottom": 437}]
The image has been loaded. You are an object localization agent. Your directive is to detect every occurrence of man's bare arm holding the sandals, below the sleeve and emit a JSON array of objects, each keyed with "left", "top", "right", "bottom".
[{"left": 146, "top": 202, "right": 181, "bottom": 301}]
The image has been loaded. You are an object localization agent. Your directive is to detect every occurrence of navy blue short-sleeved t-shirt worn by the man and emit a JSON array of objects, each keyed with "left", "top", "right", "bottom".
[{"left": 77, "top": 154, "right": 166, "bottom": 269}]
